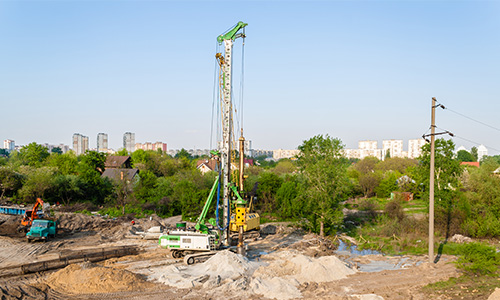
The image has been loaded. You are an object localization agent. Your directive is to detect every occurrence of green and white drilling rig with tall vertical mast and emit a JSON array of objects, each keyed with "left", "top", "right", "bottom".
[{"left": 159, "top": 22, "right": 260, "bottom": 264}]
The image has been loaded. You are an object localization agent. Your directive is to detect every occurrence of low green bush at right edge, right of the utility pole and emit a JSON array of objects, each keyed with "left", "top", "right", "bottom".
[{"left": 457, "top": 243, "right": 499, "bottom": 275}]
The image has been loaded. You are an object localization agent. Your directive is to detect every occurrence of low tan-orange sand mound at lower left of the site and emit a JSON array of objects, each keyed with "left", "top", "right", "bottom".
[{"left": 46, "top": 263, "right": 154, "bottom": 294}]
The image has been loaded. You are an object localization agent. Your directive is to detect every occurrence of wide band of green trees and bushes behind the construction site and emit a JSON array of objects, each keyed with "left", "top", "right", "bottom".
[{"left": 0, "top": 135, "right": 500, "bottom": 236}]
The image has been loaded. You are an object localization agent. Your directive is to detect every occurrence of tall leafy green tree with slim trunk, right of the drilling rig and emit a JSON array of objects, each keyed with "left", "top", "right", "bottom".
[{"left": 298, "top": 135, "right": 349, "bottom": 236}]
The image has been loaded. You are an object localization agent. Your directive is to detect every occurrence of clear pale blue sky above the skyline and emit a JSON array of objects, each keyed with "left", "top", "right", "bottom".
[{"left": 0, "top": 0, "right": 500, "bottom": 154}]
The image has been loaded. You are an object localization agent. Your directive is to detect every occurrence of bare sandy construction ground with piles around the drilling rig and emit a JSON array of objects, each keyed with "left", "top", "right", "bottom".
[{"left": 0, "top": 213, "right": 478, "bottom": 299}]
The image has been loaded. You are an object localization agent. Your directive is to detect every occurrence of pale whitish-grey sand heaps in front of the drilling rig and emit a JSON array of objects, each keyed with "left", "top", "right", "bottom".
[{"left": 148, "top": 250, "right": 355, "bottom": 299}]
